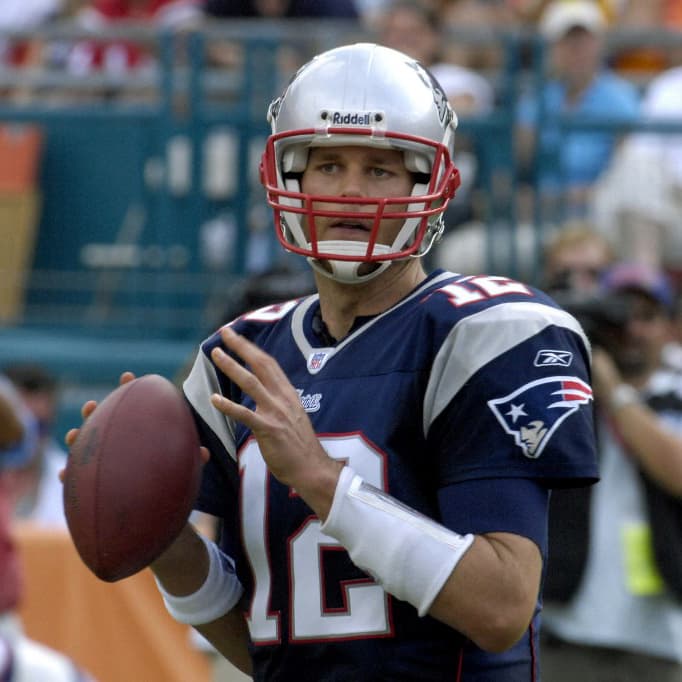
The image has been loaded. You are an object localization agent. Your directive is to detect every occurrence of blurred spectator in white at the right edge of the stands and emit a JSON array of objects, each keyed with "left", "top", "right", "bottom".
[{"left": 592, "top": 61, "right": 682, "bottom": 279}]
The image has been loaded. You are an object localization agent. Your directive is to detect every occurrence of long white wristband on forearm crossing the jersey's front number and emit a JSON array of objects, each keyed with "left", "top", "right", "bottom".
[{"left": 321, "top": 467, "right": 474, "bottom": 616}]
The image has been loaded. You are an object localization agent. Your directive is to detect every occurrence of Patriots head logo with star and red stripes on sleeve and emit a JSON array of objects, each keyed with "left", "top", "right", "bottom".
[{"left": 488, "top": 376, "right": 592, "bottom": 459}]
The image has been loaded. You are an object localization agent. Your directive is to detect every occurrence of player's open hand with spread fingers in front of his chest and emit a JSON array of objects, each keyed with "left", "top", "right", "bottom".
[{"left": 211, "top": 327, "right": 343, "bottom": 519}]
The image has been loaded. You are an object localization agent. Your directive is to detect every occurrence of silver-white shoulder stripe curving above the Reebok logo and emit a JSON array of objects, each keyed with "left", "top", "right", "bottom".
[{"left": 423, "top": 301, "right": 590, "bottom": 434}]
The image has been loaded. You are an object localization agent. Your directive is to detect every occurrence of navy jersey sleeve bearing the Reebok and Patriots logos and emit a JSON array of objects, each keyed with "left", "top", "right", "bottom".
[{"left": 427, "top": 309, "right": 597, "bottom": 485}]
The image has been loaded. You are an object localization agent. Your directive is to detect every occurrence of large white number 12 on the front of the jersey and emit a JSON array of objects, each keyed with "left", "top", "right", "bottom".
[{"left": 239, "top": 434, "right": 391, "bottom": 644}]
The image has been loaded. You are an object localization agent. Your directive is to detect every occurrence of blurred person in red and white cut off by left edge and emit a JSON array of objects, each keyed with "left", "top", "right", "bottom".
[{"left": 0, "top": 377, "right": 92, "bottom": 682}]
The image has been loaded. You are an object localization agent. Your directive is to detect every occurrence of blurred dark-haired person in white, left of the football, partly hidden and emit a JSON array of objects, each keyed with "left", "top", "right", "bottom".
[{"left": 4, "top": 364, "right": 66, "bottom": 528}]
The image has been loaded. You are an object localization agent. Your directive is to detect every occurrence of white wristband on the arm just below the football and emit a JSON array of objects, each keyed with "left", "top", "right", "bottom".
[{"left": 156, "top": 536, "right": 244, "bottom": 625}]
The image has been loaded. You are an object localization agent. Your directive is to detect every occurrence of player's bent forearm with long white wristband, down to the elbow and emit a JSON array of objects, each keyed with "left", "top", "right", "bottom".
[{"left": 322, "top": 467, "right": 542, "bottom": 651}]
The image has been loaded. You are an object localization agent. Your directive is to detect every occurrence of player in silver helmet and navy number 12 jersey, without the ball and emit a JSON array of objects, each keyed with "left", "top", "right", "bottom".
[{"left": 73, "top": 44, "right": 597, "bottom": 682}]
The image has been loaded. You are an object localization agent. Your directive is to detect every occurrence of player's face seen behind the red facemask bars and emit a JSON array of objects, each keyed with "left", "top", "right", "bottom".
[{"left": 301, "top": 146, "right": 414, "bottom": 244}]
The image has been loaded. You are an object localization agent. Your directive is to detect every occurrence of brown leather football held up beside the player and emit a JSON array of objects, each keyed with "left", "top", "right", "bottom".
[{"left": 64, "top": 374, "right": 202, "bottom": 582}]
